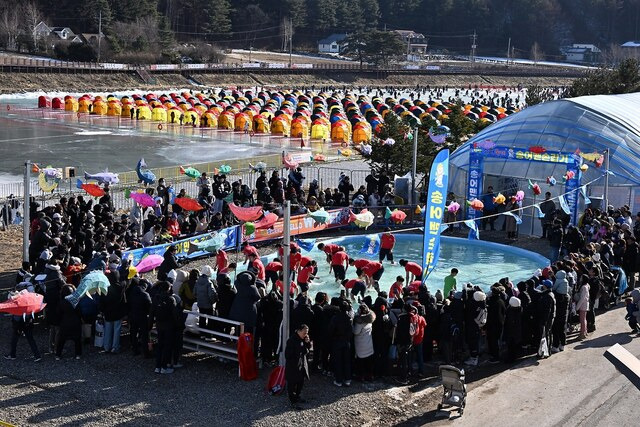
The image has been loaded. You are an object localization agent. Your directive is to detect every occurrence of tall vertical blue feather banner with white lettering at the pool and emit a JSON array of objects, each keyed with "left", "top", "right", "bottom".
[{"left": 422, "top": 149, "right": 449, "bottom": 281}]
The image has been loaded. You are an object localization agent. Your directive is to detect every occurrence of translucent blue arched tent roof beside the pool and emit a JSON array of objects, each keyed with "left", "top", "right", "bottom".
[{"left": 451, "top": 93, "right": 640, "bottom": 186}]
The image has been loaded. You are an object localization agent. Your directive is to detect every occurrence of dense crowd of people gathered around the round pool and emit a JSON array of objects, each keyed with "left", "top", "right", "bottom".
[{"left": 5, "top": 156, "right": 640, "bottom": 407}]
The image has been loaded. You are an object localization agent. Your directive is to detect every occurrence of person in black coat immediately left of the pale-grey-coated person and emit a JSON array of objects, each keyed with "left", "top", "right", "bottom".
[{"left": 328, "top": 300, "right": 353, "bottom": 387}]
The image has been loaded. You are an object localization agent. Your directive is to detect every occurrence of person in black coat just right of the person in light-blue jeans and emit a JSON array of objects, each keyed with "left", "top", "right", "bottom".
[{"left": 128, "top": 276, "right": 151, "bottom": 358}]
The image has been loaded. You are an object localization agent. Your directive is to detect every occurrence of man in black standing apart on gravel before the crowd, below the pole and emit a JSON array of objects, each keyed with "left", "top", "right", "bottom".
[{"left": 284, "top": 324, "right": 311, "bottom": 410}]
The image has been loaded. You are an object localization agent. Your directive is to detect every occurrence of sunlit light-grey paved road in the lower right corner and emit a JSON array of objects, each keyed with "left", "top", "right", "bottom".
[{"left": 436, "top": 306, "right": 640, "bottom": 427}]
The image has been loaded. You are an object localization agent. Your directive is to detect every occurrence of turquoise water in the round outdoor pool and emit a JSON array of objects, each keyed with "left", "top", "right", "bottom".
[{"left": 263, "top": 234, "right": 549, "bottom": 298}]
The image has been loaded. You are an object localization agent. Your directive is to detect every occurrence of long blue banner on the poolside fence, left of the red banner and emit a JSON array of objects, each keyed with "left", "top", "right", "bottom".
[{"left": 122, "top": 225, "right": 242, "bottom": 265}]
